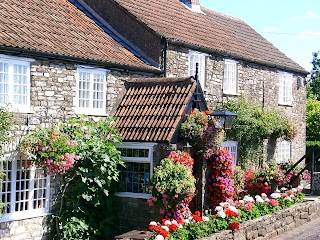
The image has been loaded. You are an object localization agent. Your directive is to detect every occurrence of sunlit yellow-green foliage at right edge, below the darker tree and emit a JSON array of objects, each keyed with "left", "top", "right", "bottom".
[{"left": 306, "top": 99, "right": 320, "bottom": 141}]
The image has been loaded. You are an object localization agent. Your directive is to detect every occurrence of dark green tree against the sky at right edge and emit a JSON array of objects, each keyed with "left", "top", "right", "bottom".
[{"left": 307, "top": 51, "right": 320, "bottom": 101}]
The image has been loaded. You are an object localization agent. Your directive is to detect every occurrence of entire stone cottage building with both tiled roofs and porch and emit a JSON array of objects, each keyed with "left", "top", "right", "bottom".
[{"left": 0, "top": 0, "right": 307, "bottom": 240}]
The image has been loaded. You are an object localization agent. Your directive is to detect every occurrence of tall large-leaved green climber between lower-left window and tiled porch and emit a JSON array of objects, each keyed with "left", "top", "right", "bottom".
[{"left": 46, "top": 117, "right": 123, "bottom": 240}]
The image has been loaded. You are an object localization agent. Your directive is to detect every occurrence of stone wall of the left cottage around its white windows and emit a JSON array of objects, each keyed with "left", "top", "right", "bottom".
[{"left": 0, "top": 58, "right": 150, "bottom": 240}]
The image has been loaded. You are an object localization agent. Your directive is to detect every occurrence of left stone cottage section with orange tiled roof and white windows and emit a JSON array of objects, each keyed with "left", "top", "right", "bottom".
[{"left": 0, "top": 0, "right": 161, "bottom": 240}]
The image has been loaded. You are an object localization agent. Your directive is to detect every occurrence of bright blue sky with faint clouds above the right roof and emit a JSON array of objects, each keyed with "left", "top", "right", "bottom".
[{"left": 200, "top": 0, "right": 320, "bottom": 71}]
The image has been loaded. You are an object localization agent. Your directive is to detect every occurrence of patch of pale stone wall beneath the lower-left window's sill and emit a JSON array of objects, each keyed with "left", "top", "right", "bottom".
[{"left": 0, "top": 217, "right": 46, "bottom": 240}]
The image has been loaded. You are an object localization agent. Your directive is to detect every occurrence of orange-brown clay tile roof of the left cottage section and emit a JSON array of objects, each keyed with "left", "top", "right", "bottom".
[{"left": 0, "top": 0, "right": 152, "bottom": 69}]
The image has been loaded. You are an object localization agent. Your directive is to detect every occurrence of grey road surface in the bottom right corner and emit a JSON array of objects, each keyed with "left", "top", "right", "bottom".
[{"left": 270, "top": 216, "right": 320, "bottom": 240}]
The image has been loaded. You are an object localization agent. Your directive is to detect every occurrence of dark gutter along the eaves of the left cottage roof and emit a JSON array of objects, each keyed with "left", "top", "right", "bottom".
[{"left": 0, "top": 46, "right": 163, "bottom": 75}]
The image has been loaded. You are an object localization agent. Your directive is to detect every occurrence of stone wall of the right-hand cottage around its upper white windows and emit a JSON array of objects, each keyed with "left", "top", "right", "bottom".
[{"left": 166, "top": 45, "right": 306, "bottom": 161}]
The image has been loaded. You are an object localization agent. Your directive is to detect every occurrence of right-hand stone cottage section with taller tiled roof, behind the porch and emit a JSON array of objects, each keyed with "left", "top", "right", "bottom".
[{"left": 76, "top": 0, "right": 308, "bottom": 231}]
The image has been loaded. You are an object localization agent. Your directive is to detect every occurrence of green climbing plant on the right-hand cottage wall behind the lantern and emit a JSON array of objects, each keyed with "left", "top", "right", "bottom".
[{"left": 224, "top": 97, "right": 297, "bottom": 168}]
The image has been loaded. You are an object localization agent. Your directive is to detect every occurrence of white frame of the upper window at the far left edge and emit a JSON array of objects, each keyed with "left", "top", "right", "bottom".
[{"left": 0, "top": 54, "right": 34, "bottom": 113}]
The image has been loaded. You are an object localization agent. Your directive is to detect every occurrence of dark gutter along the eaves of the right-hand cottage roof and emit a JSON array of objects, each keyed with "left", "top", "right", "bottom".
[{"left": 167, "top": 38, "right": 309, "bottom": 75}]
